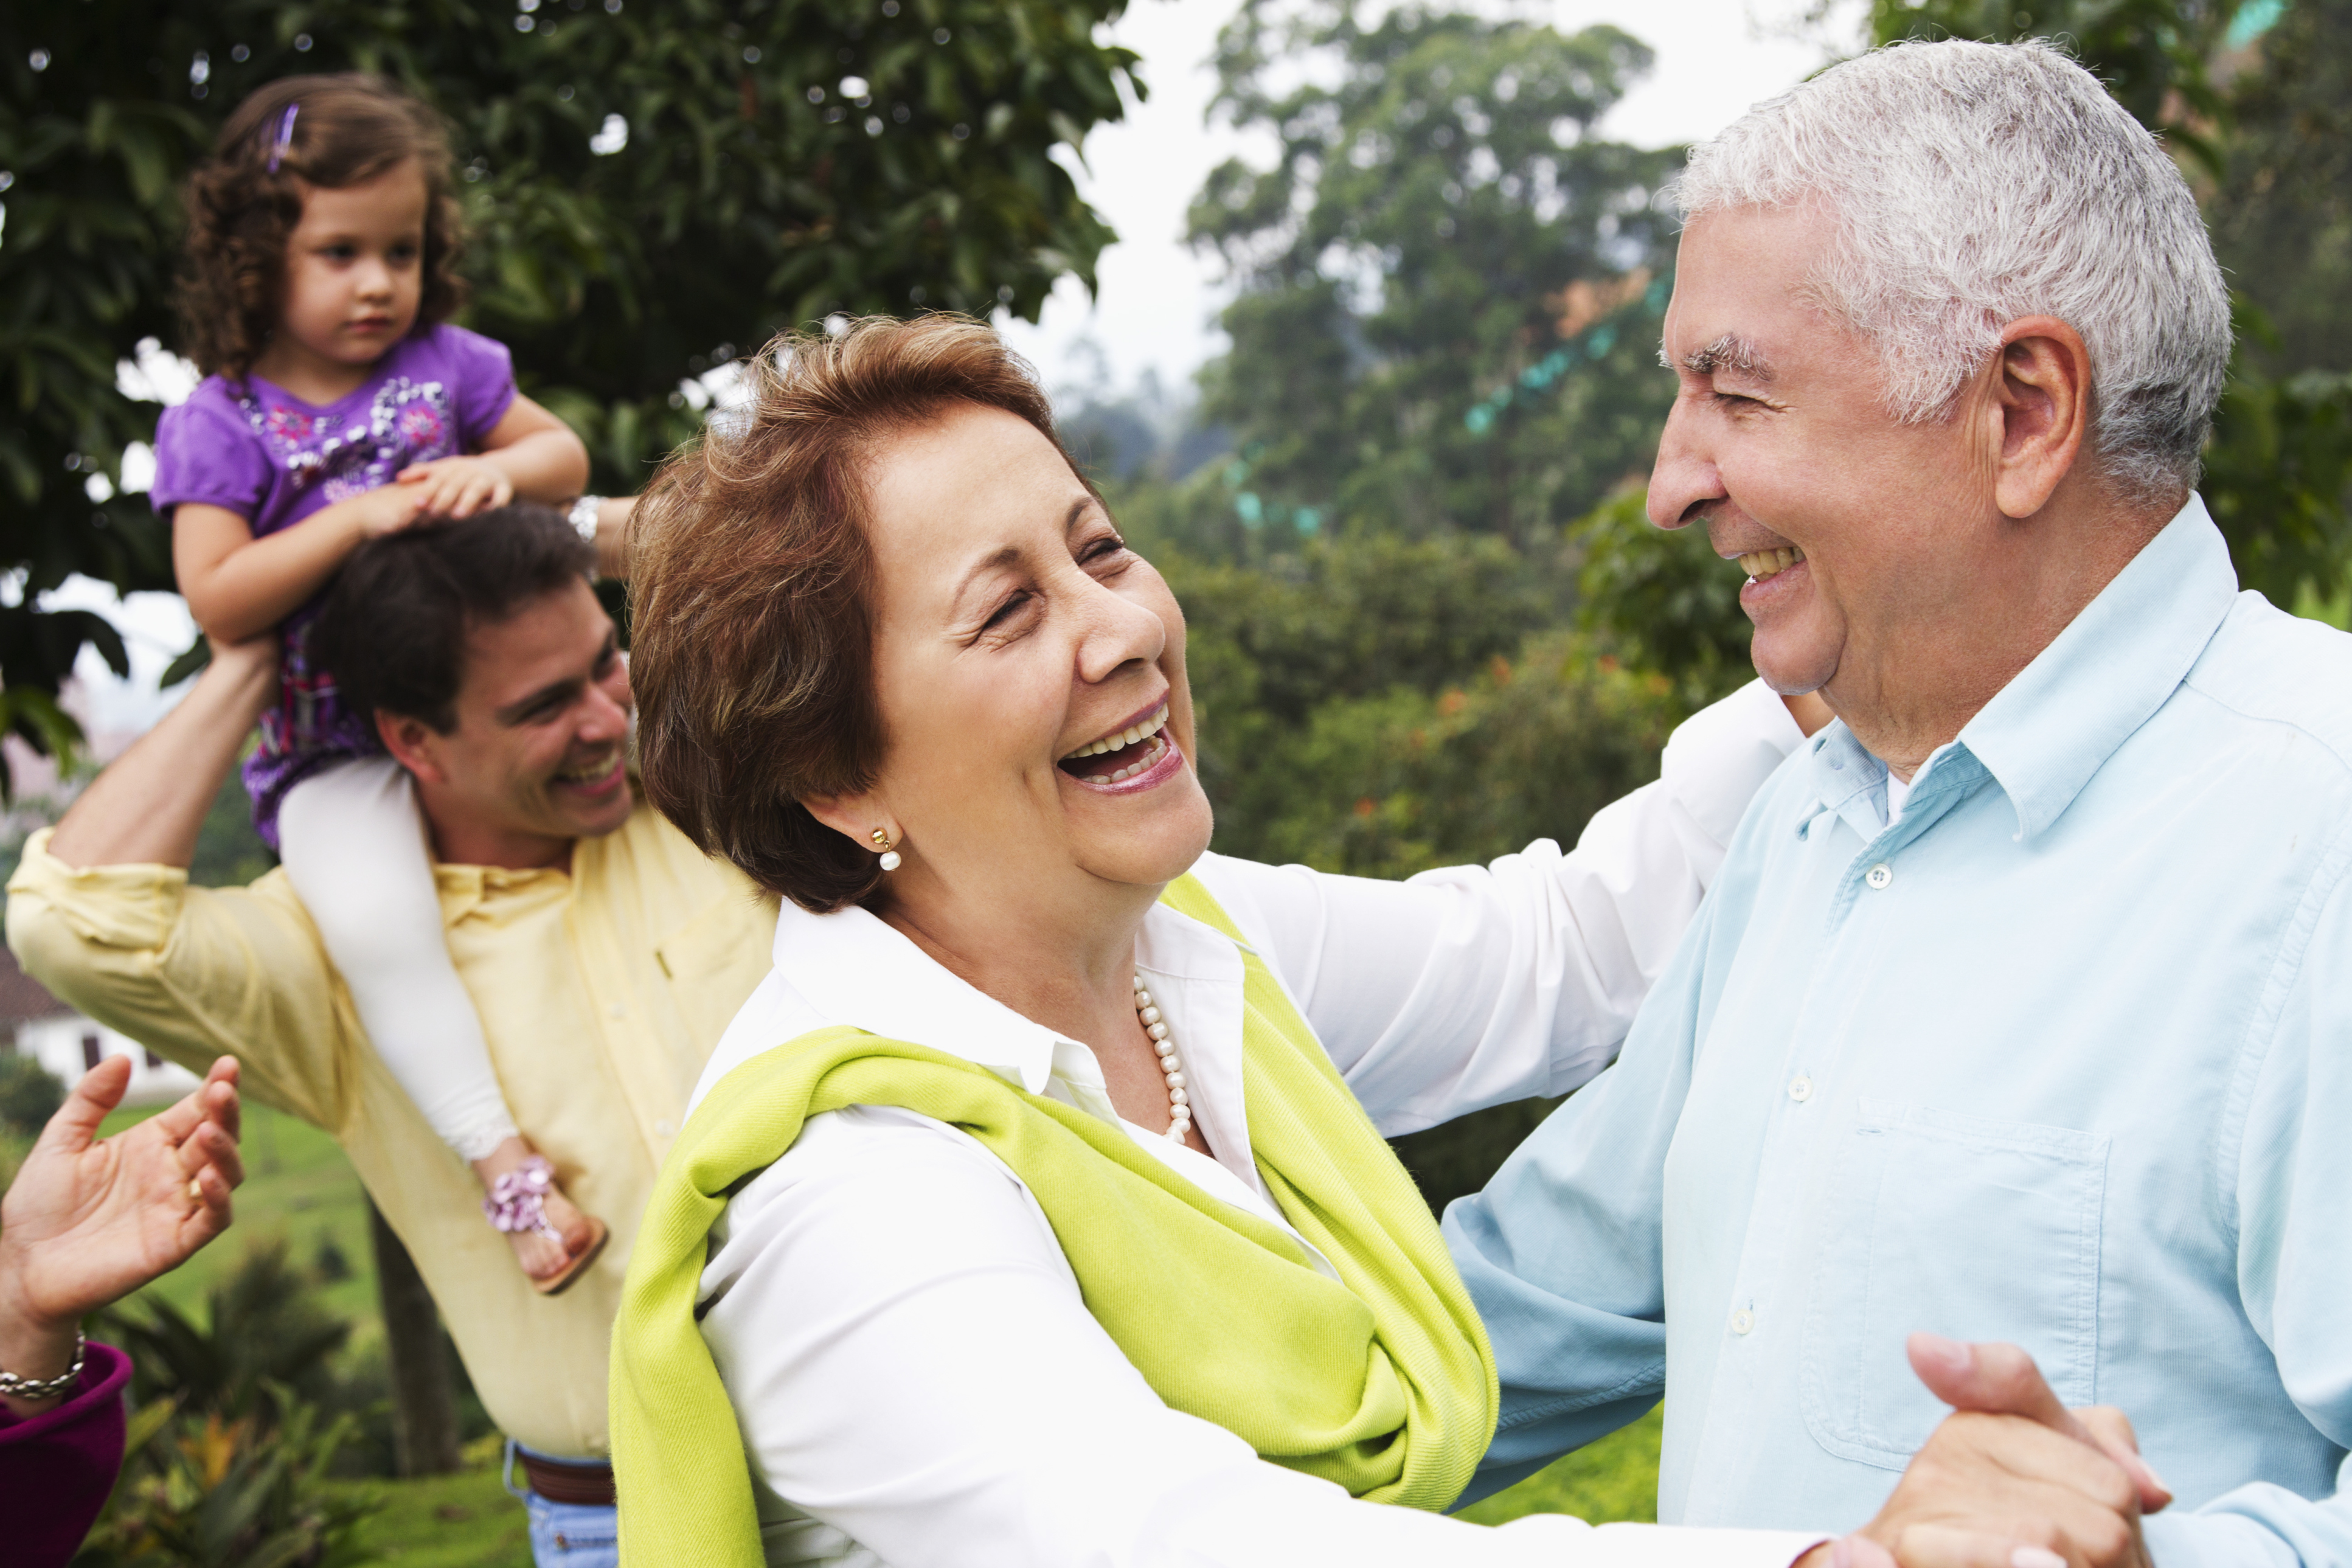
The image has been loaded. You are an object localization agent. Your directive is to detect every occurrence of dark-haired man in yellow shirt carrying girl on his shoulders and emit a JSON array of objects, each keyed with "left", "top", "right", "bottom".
[{"left": 7, "top": 508, "right": 776, "bottom": 1568}]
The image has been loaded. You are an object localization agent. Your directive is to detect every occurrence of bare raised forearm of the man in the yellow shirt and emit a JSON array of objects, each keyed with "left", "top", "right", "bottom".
[{"left": 49, "top": 637, "right": 277, "bottom": 870}]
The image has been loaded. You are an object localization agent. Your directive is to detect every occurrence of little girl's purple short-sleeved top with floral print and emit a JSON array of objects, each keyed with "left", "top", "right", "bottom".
[{"left": 148, "top": 327, "right": 515, "bottom": 848}]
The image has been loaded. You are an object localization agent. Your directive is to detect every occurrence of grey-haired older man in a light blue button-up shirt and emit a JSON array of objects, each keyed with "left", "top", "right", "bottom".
[{"left": 1446, "top": 43, "right": 2352, "bottom": 1568}]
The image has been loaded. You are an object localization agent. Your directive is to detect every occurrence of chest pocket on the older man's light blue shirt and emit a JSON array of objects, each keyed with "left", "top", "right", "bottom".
[{"left": 1802, "top": 1100, "right": 2107, "bottom": 1469}]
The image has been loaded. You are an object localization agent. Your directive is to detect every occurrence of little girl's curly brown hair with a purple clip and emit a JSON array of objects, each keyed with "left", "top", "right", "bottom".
[{"left": 174, "top": 71, "right": 466, "bottom": 381}]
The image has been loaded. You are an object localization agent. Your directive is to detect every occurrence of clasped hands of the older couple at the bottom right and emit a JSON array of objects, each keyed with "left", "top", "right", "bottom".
[{"left": 1799, "top": 1333, "right": 2171, "bottom": 1568}]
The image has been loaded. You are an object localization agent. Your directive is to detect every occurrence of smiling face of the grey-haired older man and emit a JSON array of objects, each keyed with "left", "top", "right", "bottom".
[{"left": 1649, "top": 209, "right": 1999, "bottom": 707}]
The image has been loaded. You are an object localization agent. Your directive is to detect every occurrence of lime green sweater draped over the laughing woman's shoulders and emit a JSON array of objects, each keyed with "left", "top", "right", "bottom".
[{"left": 611, "top": 877, "right": 1496, "bottom": 1568}]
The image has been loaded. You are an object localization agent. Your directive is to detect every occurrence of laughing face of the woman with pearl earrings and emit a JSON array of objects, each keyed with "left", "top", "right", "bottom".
[{"left": 832, "top": 404, "right": 1209, "bottom": 907}]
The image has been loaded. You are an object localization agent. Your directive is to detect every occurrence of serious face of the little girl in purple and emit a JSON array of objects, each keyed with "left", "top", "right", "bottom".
[{"left": 273, "top": 158, "right": 428, "bottom": 369}]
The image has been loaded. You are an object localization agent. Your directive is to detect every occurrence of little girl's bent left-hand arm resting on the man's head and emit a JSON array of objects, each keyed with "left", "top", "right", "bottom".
[{"left": 172, "top": 484, "right": 426, "bottom": 642}]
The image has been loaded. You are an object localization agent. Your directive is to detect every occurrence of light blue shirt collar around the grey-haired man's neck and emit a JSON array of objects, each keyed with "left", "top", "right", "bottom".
[{"left": 1799, "top": 494, "right": 2237, "bottom": 842}]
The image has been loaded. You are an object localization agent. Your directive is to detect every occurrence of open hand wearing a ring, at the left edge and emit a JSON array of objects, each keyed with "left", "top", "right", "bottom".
[{"left": 0, "top": 1055, "right": 245, "bottom": 1335}]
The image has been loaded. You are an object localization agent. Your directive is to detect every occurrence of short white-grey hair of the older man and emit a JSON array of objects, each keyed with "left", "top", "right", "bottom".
[{"left": 1674, "top": 40, "right": 2230, "bottom": 496}]
